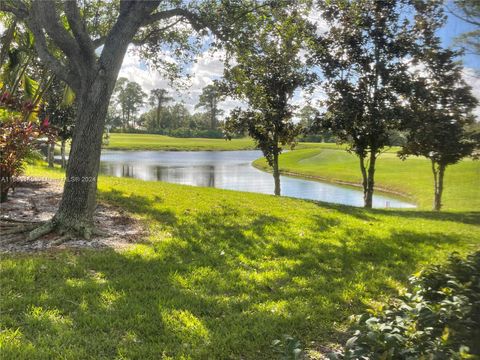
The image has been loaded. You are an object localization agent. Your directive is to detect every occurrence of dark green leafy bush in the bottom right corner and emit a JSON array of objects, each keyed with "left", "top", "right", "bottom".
[{"left": 332, "top": 252, "right": 480, "bottom": 359}]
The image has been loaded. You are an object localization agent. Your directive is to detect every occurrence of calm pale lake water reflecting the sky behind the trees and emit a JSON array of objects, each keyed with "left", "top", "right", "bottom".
[{"left": 100, "top": 150, "right": 415, "bottom": 208}]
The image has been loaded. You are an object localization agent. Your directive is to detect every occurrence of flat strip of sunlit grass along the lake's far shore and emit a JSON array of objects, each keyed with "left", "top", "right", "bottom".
[{"left": 105, "top": 133, "right": 255, "bottom": 151}]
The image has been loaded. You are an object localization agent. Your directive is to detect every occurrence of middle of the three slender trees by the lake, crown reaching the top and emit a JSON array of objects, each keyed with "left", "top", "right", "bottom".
[{"left": 315, "top": 0, "right": 439, "bottom": 208}]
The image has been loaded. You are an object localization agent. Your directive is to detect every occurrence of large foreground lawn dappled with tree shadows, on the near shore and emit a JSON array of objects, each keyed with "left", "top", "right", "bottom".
[{"left": 0, "top": 165, "right": 480, "bottom": 359}]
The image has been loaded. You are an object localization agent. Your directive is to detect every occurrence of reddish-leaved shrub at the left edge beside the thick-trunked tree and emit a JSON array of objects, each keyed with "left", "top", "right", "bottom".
[{"left": 0, "top": 90, "right": 55, "bottom": 202}]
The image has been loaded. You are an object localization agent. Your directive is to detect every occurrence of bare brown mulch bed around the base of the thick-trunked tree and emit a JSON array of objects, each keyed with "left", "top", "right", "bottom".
[{"left": 0, "top": 178, "right": 146, "bottom": 252}]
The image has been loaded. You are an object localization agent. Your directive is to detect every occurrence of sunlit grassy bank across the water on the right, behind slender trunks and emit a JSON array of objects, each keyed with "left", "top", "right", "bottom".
[{"left": 254, "top": 148, "right": 480, "bottom": 211}]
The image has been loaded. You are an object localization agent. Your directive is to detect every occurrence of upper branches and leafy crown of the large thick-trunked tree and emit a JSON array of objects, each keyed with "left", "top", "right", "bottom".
[{"left": 0, "top": 0, "right": 248, "bottom": 91}]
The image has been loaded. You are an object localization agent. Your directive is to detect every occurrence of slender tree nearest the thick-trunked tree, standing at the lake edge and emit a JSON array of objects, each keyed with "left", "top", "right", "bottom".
[{"left": 224, "top": 2, "right": 315, "bottom": 195}]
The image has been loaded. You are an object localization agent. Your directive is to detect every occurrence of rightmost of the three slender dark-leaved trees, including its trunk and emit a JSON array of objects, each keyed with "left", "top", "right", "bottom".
[{"left": 399, "top": 42, "right": 480, "bottom": 211}]
